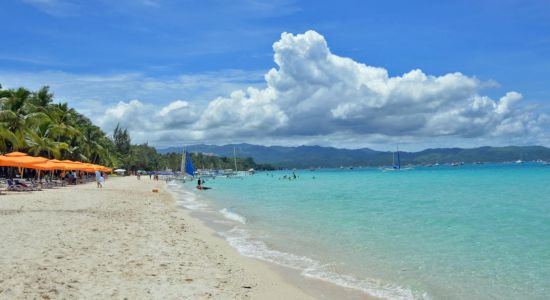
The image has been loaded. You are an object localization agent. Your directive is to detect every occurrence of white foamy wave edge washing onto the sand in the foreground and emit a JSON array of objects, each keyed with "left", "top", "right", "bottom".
[{"left": 221, "top": 227, "right": 430, "bottom": 300}]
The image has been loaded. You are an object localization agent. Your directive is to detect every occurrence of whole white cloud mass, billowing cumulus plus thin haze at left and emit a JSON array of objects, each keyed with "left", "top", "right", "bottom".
[{"left": 0, "top": 31, "right": 550, "bottom": 147}]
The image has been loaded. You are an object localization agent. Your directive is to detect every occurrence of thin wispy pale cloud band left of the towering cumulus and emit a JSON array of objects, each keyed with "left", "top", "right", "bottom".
[{"left": 0, "top": 70, "right": 265, "bottom": 109}]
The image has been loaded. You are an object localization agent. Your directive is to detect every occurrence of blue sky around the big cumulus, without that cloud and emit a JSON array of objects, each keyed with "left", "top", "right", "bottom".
[{"left": 0, "top": 0, "right": 550, "bottom": 147}]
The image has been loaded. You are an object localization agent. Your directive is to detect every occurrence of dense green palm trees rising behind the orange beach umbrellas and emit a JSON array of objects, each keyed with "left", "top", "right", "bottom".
[{"left": 0, "top": 86, "right": 118, "bottom": 166}]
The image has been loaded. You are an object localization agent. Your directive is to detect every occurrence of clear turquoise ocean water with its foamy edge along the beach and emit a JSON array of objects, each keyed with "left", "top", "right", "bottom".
[{"left": 168, "top": 164, "right": 550, "bottom": 299}]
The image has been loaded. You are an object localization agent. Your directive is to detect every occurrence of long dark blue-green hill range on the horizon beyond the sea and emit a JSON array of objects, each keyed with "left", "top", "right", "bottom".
[{"left": 157, "top": 144, "right": 550, "bottom": 168}]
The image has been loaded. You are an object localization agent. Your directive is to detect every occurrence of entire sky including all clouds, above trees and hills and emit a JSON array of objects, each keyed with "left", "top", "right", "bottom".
[{"left": 0, "top": 0, "right": 550, "bottom": 150}]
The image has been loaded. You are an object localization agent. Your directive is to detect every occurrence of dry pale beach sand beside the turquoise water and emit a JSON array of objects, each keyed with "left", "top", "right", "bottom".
[{"left": 0, "top": 177, "right": 311, "bottom": 299}]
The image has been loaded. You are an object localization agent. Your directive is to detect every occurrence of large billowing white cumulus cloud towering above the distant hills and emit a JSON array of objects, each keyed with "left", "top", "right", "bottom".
[{"left": 97, "top": 31, "right": 548, "bottom": 146}]
